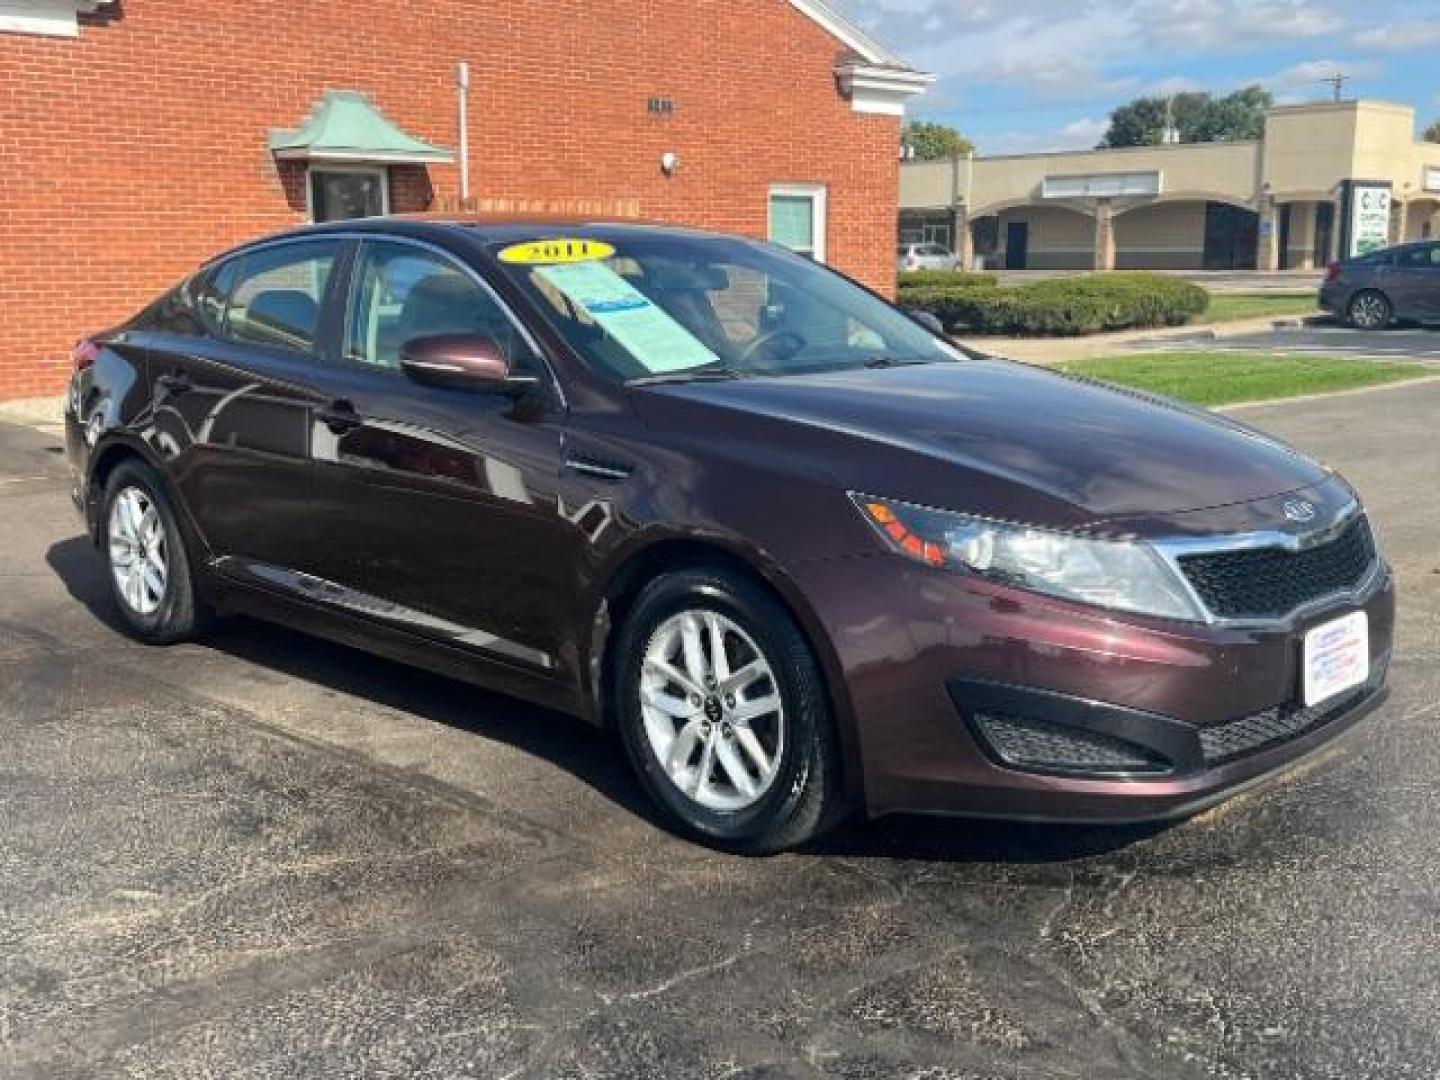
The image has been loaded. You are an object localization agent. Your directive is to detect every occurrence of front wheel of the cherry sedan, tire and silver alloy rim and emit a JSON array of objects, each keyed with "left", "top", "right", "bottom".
[{"left": 611, "top": 567, "right": 842, "bottom": 854}]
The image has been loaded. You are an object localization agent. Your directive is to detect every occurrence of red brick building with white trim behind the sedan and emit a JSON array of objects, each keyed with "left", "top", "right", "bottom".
[{"left": 0, "top": 0, "right": 927, "bottom": 399}]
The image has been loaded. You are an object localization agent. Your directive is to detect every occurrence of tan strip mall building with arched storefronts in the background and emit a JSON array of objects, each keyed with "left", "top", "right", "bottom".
[{"left": 900, "top": 101, "right": 1440, "bottom": 271}]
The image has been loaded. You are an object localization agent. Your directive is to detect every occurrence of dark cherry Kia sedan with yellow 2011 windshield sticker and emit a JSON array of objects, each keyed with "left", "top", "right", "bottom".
[{"left": 66, "top": 219, "right": 1394, "bottom": 852}]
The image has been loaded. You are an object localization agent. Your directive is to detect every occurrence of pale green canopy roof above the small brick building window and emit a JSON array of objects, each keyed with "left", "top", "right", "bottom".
[{"left": 269, "top": 91, "right": 455, "bottom": 166}]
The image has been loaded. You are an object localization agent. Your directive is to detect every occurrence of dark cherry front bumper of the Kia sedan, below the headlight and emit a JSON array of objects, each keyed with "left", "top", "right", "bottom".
[{"left": 802, "top": 556, "right": 1394, "bottom": 824}]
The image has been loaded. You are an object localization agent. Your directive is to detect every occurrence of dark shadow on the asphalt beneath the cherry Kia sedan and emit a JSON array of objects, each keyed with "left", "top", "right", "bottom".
[{"left": 46, "top": 536, "right": 1165, "bottom": 864}]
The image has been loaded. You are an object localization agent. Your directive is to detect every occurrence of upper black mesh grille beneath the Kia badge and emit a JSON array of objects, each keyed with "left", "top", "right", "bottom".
[{"left": 1179, "top": 514, "right": 1377, "bottom": 619}]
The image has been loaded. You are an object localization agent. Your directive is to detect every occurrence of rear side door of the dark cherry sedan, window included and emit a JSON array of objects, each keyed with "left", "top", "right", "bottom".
[{"left": 145, "top": 240, "right": 341, "bottom": 570}]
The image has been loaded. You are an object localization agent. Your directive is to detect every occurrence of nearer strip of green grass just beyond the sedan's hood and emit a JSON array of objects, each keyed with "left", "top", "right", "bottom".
[{"left": 1060, "top": 353, "right": 1440, "bottom": 406}]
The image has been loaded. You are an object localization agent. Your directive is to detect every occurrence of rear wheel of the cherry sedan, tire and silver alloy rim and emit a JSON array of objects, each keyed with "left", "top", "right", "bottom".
[{"left": 99, "top": 461, "right": 209, "bottom": 645}]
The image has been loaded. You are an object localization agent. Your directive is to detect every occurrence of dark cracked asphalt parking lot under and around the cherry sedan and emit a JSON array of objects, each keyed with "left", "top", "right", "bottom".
[{"left": 0, "top": 382, "right": 1440, "bottom": 1080}]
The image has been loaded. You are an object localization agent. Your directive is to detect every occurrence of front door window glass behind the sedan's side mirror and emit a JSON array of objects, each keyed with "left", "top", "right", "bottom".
[{"left": 344, "top": 242, "right": 528, "bottom": 370}]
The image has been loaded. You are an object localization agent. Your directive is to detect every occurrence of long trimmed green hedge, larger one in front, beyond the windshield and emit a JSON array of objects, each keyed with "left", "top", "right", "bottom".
[{"left": 900, "top": 272, "right": 1210, "bottom": 337}]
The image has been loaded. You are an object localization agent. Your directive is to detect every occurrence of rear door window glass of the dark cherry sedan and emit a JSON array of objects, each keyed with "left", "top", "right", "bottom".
[{"left": 225, "top": 240, "right": 337, "bottom": 356}]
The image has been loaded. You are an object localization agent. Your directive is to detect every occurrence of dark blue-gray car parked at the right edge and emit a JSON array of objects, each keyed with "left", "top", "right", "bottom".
[{"left": 1320, "top": 240, "right": 1440, "bottom": 330}]
